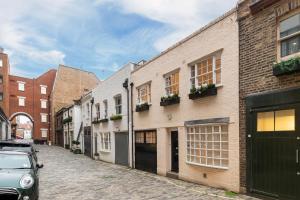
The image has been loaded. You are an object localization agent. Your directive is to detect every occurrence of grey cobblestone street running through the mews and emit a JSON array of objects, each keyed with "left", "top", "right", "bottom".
[{"left": 37, "top": 146, "right": 253, "bottom": 200}]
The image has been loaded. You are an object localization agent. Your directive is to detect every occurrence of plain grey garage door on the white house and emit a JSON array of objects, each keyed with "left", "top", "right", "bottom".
[{"left": 115, "top": 132, "right": 128, "bottom": 166}]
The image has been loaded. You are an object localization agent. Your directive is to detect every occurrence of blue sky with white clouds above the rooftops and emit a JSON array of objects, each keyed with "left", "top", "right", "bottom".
[{"left": 0, "top": 0, "right": 237, "bottom": 80}]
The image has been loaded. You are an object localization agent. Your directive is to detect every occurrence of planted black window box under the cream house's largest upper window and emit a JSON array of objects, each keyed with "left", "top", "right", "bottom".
[{"left": 189, "top": 84, "right": 218, "bottom": 100}]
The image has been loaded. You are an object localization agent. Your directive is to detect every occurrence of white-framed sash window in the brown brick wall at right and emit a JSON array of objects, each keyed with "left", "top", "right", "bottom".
[{"left": 279, "top": 14, "right": 300, "bottom": 57}]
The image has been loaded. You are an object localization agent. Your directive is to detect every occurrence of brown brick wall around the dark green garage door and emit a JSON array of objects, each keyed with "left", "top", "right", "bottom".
[{"left": 238, "top": 0, "right": 300, "bottom": 189}]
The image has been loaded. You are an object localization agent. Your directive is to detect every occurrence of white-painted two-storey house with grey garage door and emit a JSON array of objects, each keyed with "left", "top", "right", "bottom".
[{"left": 92, "top": 63, "right": 136, "bottom": 166}]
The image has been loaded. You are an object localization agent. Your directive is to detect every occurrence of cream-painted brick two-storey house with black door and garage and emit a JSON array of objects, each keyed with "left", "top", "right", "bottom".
[{"left": 131, "top": 10, "right": 240, "bottom": 192}]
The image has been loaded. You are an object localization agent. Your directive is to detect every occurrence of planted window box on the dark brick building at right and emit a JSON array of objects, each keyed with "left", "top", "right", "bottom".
[{"left": 273, "top": 57, "right": 300, "bottom": 76}]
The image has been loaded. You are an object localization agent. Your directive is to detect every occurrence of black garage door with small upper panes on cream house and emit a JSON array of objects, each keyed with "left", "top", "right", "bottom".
[{"left": 135, "top": 131, "right": 157, "bottom": 173}]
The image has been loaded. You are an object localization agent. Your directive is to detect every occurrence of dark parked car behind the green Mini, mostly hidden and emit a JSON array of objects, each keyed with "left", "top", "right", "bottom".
[{"left": 0, "top": 141, "right": 38, "bottom": 162}]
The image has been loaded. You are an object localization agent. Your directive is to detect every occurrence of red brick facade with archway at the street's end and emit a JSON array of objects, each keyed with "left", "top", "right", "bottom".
[{"left": 8, "top": 69, "right": 56, "bottom": 140}]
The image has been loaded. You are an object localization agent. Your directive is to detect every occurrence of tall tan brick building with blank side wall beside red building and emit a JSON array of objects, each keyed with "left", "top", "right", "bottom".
[{"left": 50, "top": 65, "right": 100, "bottom": 143}]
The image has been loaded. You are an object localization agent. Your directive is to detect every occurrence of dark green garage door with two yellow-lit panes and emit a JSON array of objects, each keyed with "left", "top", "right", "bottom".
[{"left": 248, "top": 104, "right": 300, "bottom": 200}]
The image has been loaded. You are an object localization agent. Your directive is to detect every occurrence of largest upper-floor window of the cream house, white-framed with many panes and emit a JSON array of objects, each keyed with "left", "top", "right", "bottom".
[{"left": 190, "top": 53, "right": 221, "bottom": 88}]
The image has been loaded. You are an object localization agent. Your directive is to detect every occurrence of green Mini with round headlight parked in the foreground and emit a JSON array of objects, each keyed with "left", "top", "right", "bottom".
[{"left": 0, "top": 150, "right": 43, "bottom": 200}]
